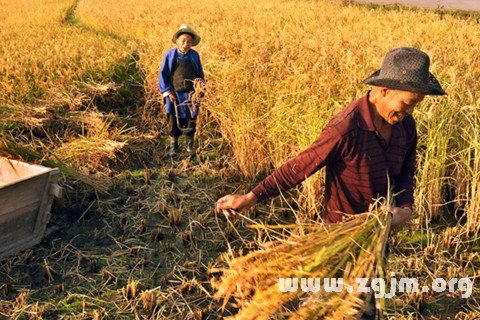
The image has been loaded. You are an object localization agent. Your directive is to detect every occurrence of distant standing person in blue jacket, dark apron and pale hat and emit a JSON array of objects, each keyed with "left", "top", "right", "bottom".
[{"left": 158, "top": 24, "right": 205, "bottom": 157}]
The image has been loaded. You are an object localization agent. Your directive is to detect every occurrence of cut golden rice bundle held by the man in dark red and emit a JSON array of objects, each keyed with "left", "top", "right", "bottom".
[{"left": 214, "top": 209, "right": 391, "bottom": 320}]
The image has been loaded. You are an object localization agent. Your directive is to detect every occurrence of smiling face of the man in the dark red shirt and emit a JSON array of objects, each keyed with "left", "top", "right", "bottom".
[{"left": 381, "top": 89, "right": 425, "bottom": 125}]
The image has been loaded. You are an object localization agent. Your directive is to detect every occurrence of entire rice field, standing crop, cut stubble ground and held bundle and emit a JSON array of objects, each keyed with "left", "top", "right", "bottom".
[{"left": 0, "top": 0, "right": 480, "bottom": 320}]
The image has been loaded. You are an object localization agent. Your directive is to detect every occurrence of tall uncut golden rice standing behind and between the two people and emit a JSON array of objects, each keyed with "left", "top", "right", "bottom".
[{"left": 71, "top": 0, "right": 480, "bottom": 226}]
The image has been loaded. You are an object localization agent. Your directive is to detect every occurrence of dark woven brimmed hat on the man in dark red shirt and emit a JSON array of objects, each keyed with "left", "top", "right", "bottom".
[{"left": 363, "top": 47, "right": 446, "bottom": 95}]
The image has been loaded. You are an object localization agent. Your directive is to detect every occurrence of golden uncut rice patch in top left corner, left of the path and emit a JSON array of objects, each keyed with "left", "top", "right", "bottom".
[{"left": 0, "top": 0, "right": 126, "bottom": 105}]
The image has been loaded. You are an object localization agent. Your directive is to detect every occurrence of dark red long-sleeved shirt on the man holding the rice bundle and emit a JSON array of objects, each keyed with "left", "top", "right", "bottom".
[{"left": 252, "top": 93, "right": 417, "bottom": 222}]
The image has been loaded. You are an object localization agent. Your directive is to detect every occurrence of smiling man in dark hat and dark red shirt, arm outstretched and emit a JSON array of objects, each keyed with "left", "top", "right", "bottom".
[{"left": 216, "top": 48, "right": 446, "bottom": 228}]
